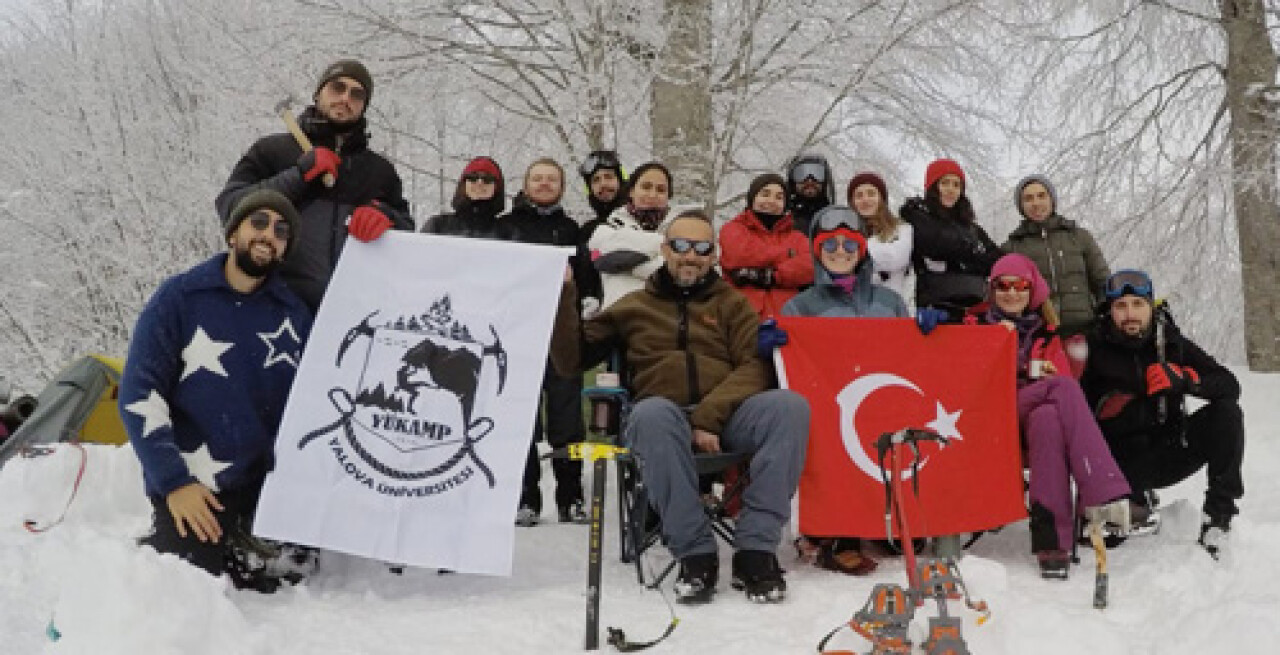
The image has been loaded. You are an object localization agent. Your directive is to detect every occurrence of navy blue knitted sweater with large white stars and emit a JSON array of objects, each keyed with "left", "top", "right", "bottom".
[{"left": 120, "top": 252, "right": 311, "bottom": 499}]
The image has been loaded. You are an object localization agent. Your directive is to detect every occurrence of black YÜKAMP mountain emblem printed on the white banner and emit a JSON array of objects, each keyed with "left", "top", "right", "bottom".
[{"left": 298, "top": 296, "right": 507, "bottom": 496}]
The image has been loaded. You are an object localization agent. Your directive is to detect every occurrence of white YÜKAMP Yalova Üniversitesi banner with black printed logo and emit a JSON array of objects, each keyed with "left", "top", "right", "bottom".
[{"left": 253, "top": 232, "right": 572, "bottom": 576}]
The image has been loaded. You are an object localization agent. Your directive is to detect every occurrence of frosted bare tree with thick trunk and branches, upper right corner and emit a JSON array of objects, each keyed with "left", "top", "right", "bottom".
[{"left": 1006, "top": 0, "right": 1280, "bottom": 371}]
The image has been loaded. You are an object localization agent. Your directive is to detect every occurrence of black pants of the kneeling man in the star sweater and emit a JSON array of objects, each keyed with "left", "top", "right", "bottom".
[{"left": 138, "top": 482, "right": 262, "bottom": 583}]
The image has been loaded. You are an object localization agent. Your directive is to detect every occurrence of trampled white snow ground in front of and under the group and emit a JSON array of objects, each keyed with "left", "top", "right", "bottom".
[{"left": 0, "top": 372, "right": 1280, "bottom": 655}]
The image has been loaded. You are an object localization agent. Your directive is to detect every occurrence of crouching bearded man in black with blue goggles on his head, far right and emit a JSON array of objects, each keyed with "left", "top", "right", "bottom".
[{"left": 1080, "top": 270, "right": 1244, "bottom": 558}]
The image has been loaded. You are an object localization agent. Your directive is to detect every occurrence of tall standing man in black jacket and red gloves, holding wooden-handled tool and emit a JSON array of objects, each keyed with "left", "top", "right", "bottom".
[{"left": 214, "top": 59, "right": 413, "bottom": 312}]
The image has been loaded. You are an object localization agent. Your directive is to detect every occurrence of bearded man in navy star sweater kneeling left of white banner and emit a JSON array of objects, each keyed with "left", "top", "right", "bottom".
[{"left": 119, "top": 189, "right": 311, "bottom": 591}]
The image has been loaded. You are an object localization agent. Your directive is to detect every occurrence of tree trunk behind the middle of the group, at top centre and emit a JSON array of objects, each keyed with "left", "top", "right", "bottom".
[{"left": 649, "top": 0, "right": 714, "bottom": 209}]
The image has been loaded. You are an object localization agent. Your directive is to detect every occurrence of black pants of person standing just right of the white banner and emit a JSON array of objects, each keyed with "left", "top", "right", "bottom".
[{"left": 520, "top": 363, "right": 585, "bottom": 512}]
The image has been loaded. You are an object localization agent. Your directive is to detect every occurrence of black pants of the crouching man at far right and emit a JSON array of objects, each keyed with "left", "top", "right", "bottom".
[{"left": 1111, "top": 400, "right": 1244, "bottom": 516}]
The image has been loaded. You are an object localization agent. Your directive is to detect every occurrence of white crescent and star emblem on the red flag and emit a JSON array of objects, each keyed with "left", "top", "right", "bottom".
[{"left": 836, "top": 374, "right": 964, "bottom": 482}]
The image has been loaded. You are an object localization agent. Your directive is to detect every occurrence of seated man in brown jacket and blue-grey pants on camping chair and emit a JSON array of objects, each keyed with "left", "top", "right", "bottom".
[{"left": 552, "top": 210, "right": 809, "bottom": 603}]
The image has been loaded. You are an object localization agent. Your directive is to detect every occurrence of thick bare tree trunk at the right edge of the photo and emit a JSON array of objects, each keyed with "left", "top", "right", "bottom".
[{"left": 1220, "top": 0, "right": 1280, "bottom": 372}]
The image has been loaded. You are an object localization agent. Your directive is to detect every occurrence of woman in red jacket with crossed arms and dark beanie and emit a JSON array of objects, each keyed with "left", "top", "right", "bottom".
[{"left": 719, "top": 173, "right": 813, "bottom": 320}]
